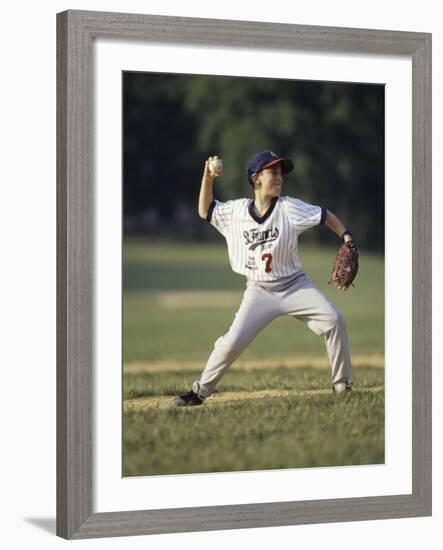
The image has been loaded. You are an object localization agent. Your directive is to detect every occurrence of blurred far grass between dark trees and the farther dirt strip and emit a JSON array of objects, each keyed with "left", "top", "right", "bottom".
[{"left": 123, "top": 240, "right": 384, "bottom": 362}]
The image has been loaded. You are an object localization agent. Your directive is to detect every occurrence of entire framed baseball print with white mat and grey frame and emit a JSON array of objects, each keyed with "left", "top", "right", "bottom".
[{"left": 57, "top": 11, "right": 431, "bottom": 538}]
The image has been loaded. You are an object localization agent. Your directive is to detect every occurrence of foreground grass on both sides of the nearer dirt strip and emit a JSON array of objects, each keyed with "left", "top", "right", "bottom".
[{"left": 123, "top": 368, "right": 384, "bottom": 476}]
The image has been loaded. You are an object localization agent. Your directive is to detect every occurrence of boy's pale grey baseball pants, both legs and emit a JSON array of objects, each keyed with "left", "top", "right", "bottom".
[{"left": 199, "top": 273, "right": 351, "bottom": 399}]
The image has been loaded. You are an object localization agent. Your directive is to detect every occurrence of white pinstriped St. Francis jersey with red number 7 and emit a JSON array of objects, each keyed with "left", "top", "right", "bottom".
[{"left": 207, "top": 197, "right": 326, "bottom": 282}]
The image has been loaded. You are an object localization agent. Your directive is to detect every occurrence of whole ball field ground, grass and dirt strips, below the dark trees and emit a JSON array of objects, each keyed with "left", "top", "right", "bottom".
[{"left": 123, "top": 241, "right": 384, "bottom": 476}]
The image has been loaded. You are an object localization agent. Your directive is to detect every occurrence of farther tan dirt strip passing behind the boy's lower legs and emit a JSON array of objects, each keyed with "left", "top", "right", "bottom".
[{"left": 124, "top": 353, "right": 385, "bottom": 374}]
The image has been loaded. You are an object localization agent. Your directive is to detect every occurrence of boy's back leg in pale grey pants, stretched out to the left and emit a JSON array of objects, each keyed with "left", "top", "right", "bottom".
[{"left": 198, "top": 285, "right": 281, "bottom": 399}]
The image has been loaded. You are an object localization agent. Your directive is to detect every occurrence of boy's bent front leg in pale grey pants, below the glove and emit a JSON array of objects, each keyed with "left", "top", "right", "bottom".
[{"left": 280, "top": 275, "right": 351, "bottom": 384}]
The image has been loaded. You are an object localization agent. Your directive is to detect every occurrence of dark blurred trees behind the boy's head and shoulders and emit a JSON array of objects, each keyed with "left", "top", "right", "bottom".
[{"left": 123, "top": 72, "right": 384, "bottom": 253}]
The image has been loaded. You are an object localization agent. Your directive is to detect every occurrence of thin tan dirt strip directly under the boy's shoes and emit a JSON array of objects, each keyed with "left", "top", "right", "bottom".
[{"left": 123, "top": 386, "right": 384, "bottom": 412}]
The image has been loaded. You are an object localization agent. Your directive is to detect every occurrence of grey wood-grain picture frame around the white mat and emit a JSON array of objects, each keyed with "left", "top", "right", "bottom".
[{"left": 57, "top": 11, "right": 432, "bottom": 539}]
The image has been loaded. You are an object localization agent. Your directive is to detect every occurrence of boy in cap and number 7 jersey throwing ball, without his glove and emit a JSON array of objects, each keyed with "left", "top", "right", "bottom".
[{"left": 174, "top": 151, "right": 355, "bottom": 407}]
